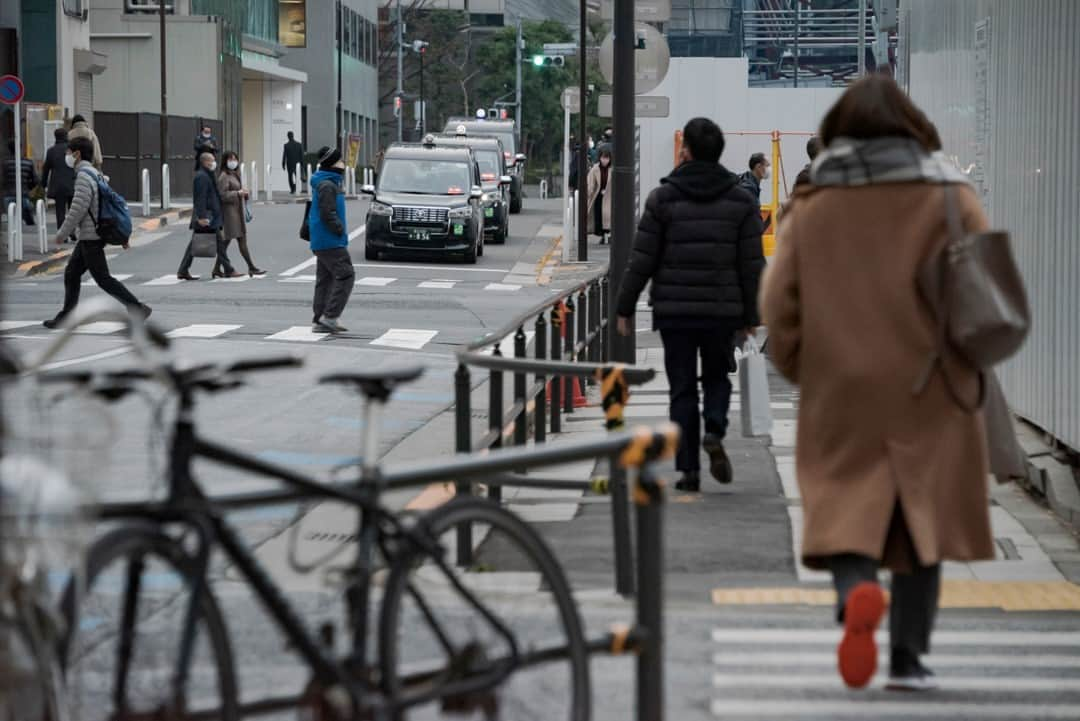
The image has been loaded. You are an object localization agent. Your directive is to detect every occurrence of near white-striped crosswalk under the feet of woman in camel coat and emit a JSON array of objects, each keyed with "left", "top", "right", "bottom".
[{"left": 711, "top": 624, "right": 1080, "bottom": 721}]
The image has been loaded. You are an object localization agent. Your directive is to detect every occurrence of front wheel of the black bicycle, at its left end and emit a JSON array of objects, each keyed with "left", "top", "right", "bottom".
[{"left": 59, "top": 525, "right": 240, "bottom": 721}]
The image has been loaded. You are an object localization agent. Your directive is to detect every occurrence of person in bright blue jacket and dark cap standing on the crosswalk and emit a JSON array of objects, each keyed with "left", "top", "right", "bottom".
[{"left": 308, "top": 147, "right": 356, "bottom": 334}]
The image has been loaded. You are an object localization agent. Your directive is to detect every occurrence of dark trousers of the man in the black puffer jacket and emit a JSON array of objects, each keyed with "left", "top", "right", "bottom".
[{"left": 660, "top": 326, "right": 735, "bottom": 472}]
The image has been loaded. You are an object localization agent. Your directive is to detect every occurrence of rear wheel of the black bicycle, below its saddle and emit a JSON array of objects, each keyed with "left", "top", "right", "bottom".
[{"left": 379, "top": 498, "right": 592, "bottom": 721}]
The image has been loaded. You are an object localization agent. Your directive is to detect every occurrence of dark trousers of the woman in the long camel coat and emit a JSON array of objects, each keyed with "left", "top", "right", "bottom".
[{"left": 826, "top": 504, "right": 942, "bottom": 657}]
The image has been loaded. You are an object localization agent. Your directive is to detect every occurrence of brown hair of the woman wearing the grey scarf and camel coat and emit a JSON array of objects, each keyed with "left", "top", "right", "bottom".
[{"left": 819, "top": 73, "right": 942, "bottom": 152}]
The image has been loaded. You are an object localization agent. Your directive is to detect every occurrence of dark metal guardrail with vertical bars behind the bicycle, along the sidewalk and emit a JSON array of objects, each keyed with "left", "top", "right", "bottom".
[{"left": 455, "top": 267, "right": 653, "bottom": 597}]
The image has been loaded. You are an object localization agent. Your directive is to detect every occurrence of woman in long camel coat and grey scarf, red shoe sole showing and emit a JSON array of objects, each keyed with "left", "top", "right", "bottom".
[{"left": 760, "top": 74, "right": 994, "bottom": 690}]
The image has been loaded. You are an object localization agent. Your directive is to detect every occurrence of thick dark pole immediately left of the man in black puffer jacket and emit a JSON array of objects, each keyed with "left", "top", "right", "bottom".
[{"left": 613, "top": 0, "right": 635, "bottom": 362}]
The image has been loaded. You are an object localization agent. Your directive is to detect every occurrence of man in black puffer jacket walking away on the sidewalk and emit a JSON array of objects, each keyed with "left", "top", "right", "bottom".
[{"left": 617, "top": 118, "right": 765, "bottom": 491}]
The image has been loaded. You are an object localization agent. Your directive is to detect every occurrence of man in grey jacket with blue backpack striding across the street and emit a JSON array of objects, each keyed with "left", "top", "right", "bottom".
[{"left": 44, "top": 138, "right": 150, "bottom": 328}]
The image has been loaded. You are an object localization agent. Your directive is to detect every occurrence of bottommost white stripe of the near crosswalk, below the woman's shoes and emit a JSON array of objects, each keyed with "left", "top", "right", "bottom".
[{"left": 711, "top": 695, "right": 1080, "bottom": 720}]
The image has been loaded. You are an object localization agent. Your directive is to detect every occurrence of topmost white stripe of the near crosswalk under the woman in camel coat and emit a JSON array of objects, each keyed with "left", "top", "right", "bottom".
[{"left": 713, "top": 628, "right": 1080, "bottom": 648}]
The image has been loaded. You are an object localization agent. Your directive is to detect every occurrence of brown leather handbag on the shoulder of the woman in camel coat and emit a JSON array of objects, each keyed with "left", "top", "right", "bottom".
[{"left": 914, "top": 183, "right": 1031, "bottom": 411}]
